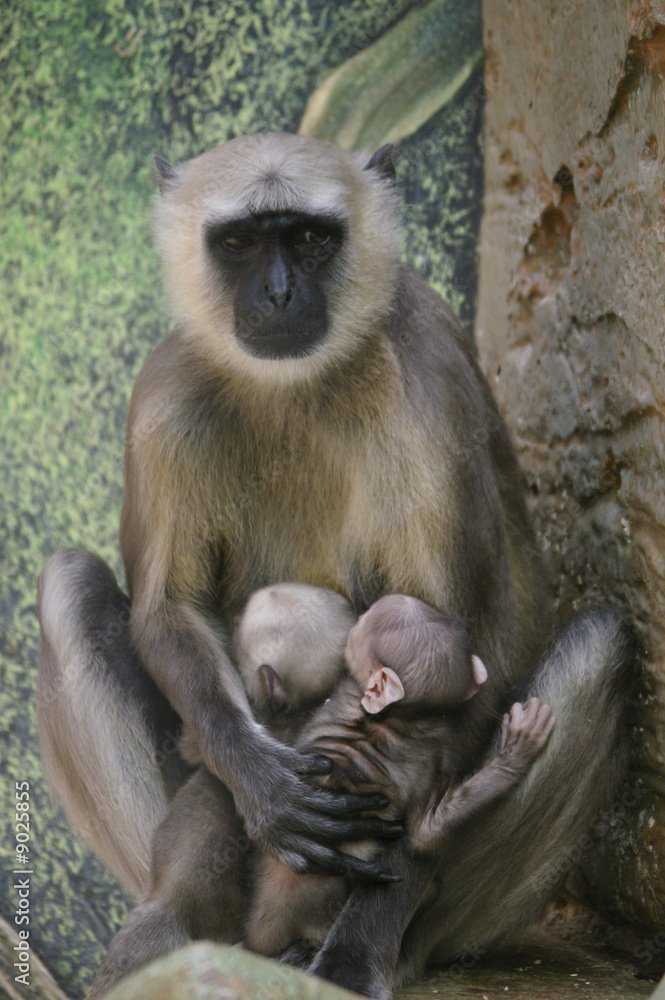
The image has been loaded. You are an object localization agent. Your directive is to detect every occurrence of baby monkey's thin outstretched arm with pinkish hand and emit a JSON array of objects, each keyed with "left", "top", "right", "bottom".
[{"left": 410, "top": 698, "right": 554, "bottom": 851}]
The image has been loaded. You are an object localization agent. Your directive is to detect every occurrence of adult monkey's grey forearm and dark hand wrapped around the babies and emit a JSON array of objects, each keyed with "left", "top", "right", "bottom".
[{"left": 132, "top": 598, "right": 401, "bottom": 881}]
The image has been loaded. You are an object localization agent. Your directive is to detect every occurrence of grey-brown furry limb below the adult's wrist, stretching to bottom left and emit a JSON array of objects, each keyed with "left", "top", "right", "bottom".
[{"left": 87, "top": 768, "right": 246, "bottom": 1000}]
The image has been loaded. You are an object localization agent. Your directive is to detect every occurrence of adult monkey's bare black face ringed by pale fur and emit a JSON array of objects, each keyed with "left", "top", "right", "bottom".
[{"left": 205, "top": 212, "right": 346, "bottom": 360}]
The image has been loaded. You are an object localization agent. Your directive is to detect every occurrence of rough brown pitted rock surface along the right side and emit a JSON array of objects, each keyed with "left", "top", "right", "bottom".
[{"left": 476, "top": 0, "right": 665, "bottom": 928}]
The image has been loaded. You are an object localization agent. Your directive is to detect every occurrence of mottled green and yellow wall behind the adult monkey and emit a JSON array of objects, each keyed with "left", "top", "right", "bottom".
[{"left": 0, "top": 0, "right": 482, "bottom": 996}]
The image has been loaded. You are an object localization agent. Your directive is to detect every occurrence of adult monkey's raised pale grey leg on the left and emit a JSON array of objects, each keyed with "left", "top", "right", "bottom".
[{"left": 37, "top": 549, "right": 189, "bottom": 896}]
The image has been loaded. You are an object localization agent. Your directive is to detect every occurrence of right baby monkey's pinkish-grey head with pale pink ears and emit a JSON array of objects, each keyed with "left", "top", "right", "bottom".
[{"left": 346, "top": 594, "right": 487, "bottom": 714}]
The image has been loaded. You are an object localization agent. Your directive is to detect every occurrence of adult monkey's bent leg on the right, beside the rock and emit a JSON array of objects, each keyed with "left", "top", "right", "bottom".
[{"left": 311, "top": 611, "right": 634, "bottom": 998}]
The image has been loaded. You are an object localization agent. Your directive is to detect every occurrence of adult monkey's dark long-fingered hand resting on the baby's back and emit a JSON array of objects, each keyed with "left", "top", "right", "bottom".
[{"left": 233, "top": 740, "right": 403, "bottom": 882}]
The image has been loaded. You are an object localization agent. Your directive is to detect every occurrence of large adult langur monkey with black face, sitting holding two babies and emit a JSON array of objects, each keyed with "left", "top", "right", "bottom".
[{"left": 38, "top": 134, "right": 630, "bottom": 997}]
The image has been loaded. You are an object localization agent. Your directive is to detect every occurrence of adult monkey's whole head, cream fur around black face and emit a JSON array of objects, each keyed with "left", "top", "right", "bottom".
[{"left": 155, "top": 133, "right": 399, "bottom": 382}]
